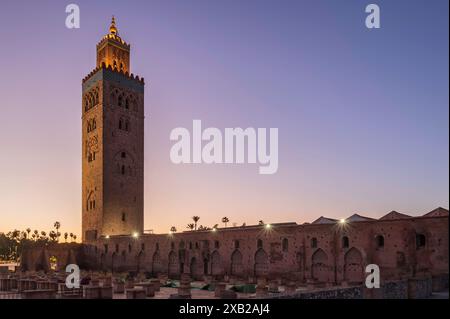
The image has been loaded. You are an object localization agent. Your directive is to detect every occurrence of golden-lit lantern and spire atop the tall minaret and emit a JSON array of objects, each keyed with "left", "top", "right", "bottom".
[{"left": 97, "top": 16, "right": 130, "bottom": 73}]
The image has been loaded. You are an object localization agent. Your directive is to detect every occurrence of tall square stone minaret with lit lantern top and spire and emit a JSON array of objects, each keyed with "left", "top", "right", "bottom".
[{"left": 82, "top": 17, "right": 144, "bottom": 242}]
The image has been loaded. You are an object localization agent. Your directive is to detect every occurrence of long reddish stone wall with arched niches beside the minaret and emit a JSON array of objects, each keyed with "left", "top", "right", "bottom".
[{"left": 22, "top": 217, "right": 448, "bottom": 292}]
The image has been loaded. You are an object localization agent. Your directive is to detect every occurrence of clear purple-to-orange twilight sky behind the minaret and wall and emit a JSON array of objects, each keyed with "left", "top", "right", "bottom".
[{"left": 0, "top": 0, "right": 449, "bottom": 238}]
